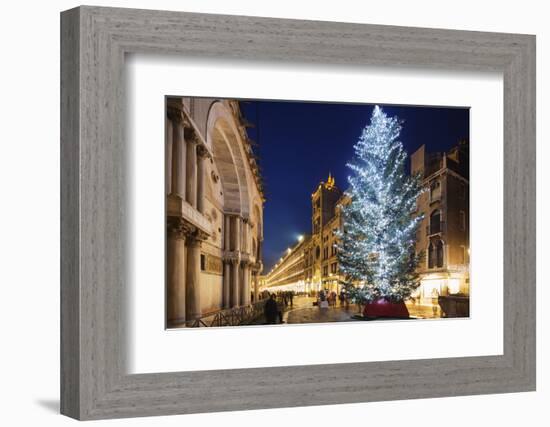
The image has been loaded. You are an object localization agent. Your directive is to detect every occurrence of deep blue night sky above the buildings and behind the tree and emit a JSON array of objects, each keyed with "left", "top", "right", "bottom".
[{"left": 241, "top": 101, "right": 469, "bottom": 271}]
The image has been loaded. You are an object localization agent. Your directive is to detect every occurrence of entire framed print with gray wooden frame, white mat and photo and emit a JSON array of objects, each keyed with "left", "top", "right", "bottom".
[{"left": 61, "top": 7, "right": 535, "bottom": 419}]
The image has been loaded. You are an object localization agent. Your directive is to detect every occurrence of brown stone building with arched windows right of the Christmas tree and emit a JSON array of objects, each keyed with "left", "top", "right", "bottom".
[{"left": 411, "top": 142, "right": 470, "bottom": 303}]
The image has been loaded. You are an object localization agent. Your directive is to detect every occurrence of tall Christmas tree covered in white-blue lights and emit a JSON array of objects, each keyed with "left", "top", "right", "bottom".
[{"left": 338, "top": 106, "right": 423, "bottom": 316}]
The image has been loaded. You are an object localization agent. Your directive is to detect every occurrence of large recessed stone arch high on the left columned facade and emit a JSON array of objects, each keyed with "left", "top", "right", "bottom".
[{"left": 206, "top": 101, "right": 250, "bottom": 218}]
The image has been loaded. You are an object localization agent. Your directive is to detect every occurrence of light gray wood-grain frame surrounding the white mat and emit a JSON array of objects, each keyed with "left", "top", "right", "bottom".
[{"left": 61, "top": 6, "right": 535, "bottom": 419}]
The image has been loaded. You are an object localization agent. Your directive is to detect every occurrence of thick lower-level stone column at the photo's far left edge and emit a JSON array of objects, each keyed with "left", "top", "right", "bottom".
[{"left": 166, "top": 229, "right": 186, "bottom": 326}]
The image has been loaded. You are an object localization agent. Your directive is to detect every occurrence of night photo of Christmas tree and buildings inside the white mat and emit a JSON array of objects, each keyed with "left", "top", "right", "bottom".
[{"left": 166, "top": 95, "right": 476, "bottom": 329}]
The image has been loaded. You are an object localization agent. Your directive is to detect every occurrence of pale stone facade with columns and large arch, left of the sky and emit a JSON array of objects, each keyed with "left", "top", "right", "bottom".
[{"left": 165, "top": 98, "right": 264, "bottom": 327}]
